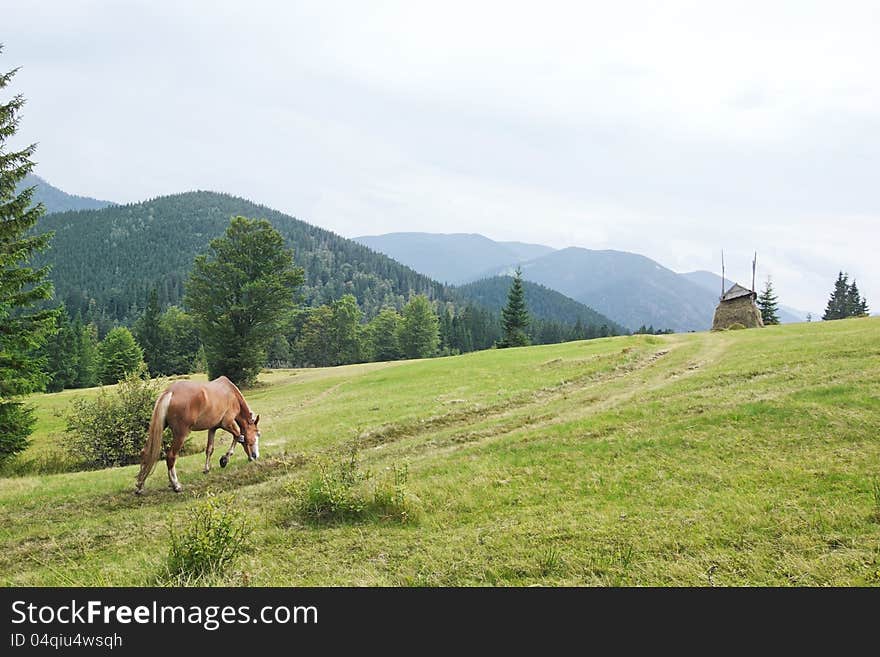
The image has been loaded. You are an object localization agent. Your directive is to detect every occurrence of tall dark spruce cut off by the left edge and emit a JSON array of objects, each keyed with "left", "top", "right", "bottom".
[{"left": 0, "top": 46, "right": 57, "bottom": 461}]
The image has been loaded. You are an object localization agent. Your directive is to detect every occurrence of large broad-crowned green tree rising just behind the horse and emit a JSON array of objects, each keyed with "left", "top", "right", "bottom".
[{"left": 186, "top": 217, "right": 303, "bottom": 386}]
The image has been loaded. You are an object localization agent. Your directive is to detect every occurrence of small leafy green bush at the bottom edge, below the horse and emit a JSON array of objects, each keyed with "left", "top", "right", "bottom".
[{"left": 167, "top": 495, "right": 253, "bottom": 584}]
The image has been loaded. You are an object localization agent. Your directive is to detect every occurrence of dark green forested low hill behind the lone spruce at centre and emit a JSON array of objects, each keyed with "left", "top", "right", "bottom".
[{"left": 456, "top": 276, "right": 626, "bottom": 333}]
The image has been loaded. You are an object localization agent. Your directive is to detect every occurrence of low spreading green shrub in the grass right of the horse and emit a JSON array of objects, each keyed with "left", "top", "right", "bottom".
[{"left": 287, "top": 450, "right": 418, "bottom": 524}]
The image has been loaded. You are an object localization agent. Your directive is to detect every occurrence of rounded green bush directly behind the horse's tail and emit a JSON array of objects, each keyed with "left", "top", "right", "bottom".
[{"left": 67, "top": 365, "right": 170, "bottom": 468}]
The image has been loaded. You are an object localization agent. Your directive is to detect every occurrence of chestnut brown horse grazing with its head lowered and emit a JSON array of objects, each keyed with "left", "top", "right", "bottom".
[{"left": 134, "top": 376, "right": 260, "bottom": 495}]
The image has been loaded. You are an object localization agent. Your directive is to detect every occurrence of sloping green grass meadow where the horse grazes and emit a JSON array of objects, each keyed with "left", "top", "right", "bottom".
[{"left": 0, "top": 319, "right": 880, "bottom": 586}]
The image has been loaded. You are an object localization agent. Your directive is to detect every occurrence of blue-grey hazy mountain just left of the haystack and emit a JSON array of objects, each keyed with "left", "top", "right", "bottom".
[{"left": 488, "top": 247, "right": 718, "bottom": 332}]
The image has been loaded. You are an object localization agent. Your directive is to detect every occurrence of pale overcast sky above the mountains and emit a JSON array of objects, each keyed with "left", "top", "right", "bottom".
[{"left": 0, "top": 0, "right": 880, "bottom": 312}]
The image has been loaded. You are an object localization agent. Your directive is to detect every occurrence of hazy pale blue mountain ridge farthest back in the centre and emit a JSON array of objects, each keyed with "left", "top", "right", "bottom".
[{"left": 354, "top": 233, "right": 553, "bottom": 284}]
